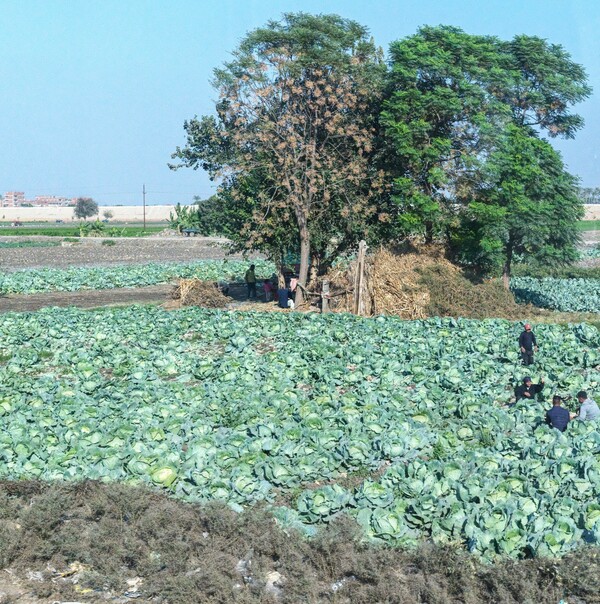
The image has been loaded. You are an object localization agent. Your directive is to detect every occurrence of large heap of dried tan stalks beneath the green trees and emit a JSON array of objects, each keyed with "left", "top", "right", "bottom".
[{"left": 328, "top": 246, "right": 523, "bottom": 319}]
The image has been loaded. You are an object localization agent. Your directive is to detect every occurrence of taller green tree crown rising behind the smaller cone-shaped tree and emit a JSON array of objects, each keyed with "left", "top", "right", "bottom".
[{"left": 381, "top": 26, "right": 590, "bottom": 248}]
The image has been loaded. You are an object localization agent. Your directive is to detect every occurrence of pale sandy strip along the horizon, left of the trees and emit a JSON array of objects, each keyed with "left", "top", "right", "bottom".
[{"left": 0, "top": 205, "right": 175, "bottom": 222}]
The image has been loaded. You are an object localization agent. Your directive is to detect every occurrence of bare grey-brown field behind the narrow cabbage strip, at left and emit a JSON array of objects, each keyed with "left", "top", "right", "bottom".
[{"left": 0, "top": 236, "right": 241, "bottom": 272}]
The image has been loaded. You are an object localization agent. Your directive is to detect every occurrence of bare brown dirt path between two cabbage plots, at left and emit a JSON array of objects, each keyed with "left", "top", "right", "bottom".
[{"left": 0, "top": 283, "right": 173, "bottom": 313}]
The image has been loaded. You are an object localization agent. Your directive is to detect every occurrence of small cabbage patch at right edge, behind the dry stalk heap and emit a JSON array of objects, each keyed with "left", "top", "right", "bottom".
[{"left": 510, "top": 277, "right": 600, "bottom": 313}]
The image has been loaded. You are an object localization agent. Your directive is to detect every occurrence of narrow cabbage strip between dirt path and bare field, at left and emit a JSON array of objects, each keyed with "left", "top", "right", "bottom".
[{"left": 0, "top": 260, "right": 274, "bottom": 294}]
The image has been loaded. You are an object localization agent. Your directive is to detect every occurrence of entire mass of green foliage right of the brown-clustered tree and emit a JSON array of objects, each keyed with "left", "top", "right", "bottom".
[{"left": 380, "top": 26, "right": 591, "bottom": 266}]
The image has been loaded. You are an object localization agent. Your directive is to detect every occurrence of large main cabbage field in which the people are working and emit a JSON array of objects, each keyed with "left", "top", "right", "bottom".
[{"left": 0, "top": 307, "right": 600, "bottom": 559}]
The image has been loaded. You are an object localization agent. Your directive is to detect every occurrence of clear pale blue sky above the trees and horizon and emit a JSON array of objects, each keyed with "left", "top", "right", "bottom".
[{"left": 0, "top": 0, "right": 600, "bottom": 204}]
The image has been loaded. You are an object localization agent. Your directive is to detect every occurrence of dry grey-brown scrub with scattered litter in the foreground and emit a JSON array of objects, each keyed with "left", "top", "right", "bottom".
[{"left": 0, "top": 482, "right": 600, "bottom": 604}]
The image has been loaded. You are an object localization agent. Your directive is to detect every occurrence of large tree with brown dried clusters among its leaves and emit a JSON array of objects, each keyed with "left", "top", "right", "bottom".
[{"left": 174, "top": 13, "right": 383, "bottom": 300}]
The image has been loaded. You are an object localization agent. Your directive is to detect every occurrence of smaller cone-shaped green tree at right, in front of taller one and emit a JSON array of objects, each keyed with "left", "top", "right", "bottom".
[{"left": 453, "top": 124, "right": 584, "bottom": 289}]
